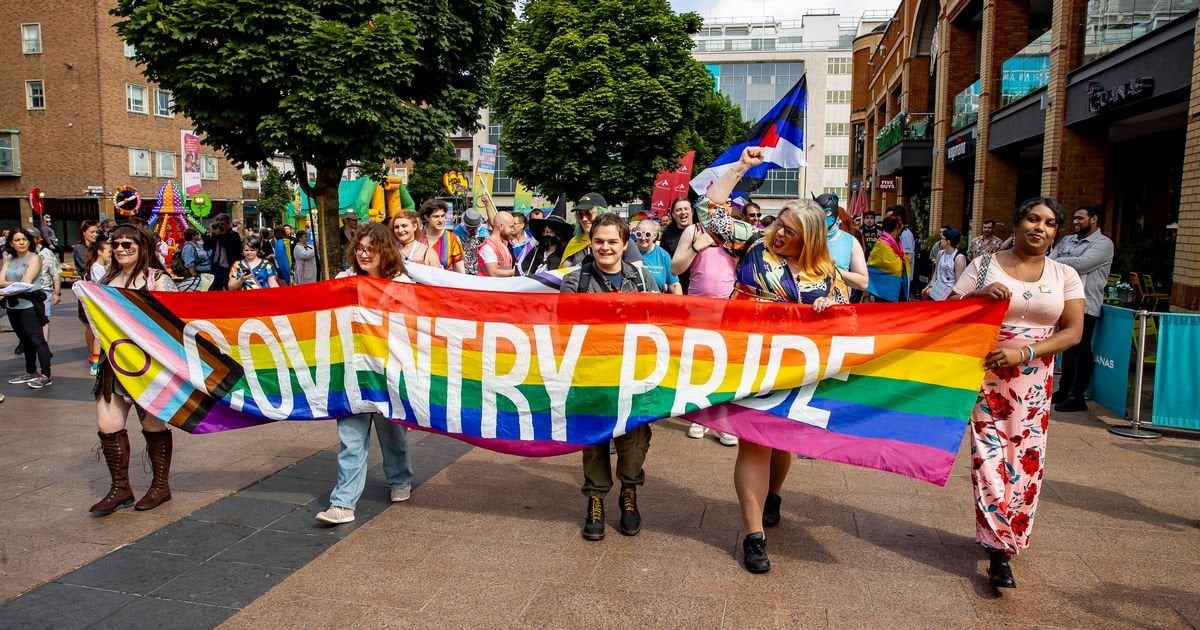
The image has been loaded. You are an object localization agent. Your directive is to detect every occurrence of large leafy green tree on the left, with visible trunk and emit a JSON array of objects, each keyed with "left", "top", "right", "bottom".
[{"left": 113, "top": 0, "right": 514, "bottom": 274}]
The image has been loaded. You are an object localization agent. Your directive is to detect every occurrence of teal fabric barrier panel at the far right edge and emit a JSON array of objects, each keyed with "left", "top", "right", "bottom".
[{"left": 1151, "top": 313, "right": 1200, "bottom": 431}]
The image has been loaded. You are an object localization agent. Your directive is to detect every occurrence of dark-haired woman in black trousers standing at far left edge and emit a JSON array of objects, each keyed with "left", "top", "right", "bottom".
[{"left": 0, "top": 228, "right": 54, "bottom": 389}]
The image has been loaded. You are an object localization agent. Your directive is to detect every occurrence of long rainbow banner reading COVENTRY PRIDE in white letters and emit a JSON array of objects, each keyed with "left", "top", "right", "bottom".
[{"left": 74, "top": 277, "right": 1006, "bottom": 485}]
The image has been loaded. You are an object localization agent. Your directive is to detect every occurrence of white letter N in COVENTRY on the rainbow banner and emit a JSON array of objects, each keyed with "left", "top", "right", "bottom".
[{"left": 384, "top": 313, "right": 433, "bottom": 427}]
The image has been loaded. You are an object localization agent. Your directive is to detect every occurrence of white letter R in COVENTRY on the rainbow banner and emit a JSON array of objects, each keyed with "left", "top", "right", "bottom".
[{"left": 479, "top": 322, "right": 533, "bottom": 440}]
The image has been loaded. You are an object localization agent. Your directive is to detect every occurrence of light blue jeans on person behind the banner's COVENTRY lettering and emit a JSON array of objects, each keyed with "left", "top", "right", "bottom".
[{"left": 329, "top": 414, "right": 413, "bottom": 510}]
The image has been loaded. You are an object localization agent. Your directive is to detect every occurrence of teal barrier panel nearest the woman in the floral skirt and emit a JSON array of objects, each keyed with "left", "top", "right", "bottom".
[{"left": 1087, "top": 305, "right": 1132, "bottom": 416}]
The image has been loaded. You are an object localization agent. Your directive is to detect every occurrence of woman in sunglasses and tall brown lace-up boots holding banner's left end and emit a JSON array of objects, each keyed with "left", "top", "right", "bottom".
[{"left": 89, "top": 224, "right": 175, "bottom": 516}]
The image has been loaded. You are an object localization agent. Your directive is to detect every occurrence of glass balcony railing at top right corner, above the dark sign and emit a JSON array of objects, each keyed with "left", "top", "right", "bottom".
[{"left": 1084, "top": 0, "right": 1200, "bottom": 64}]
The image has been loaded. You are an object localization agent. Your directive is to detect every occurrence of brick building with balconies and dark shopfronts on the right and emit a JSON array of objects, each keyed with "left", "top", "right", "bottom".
[{"left": 850, "top": 0, "right": 1200, "bottom": 310}]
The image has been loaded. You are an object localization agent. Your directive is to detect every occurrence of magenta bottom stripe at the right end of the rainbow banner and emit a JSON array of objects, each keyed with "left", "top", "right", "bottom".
[{"left": 683, "top": 403, "right": 955, "bottom": 486}]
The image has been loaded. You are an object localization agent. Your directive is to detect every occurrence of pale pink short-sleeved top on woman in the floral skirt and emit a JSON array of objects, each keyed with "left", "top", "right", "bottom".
[{"left": 954, "top": 257, "right": 1084, "bottom": 328}]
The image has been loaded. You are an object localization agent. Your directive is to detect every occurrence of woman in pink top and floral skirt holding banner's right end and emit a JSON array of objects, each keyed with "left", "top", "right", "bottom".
[{"left": 952, "top": 197, "right": 1084, "bottom": 588}]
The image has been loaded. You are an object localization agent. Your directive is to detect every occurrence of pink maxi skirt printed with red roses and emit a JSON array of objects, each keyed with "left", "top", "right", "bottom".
[{"left": 971, "top": 325, "right": 1054, "bottom": 554}]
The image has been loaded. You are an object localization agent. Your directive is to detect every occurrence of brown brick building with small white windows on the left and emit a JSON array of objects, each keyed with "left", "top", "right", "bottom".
[{"left": 0, "top": 0, "right": 244, "bottom": 253}]
